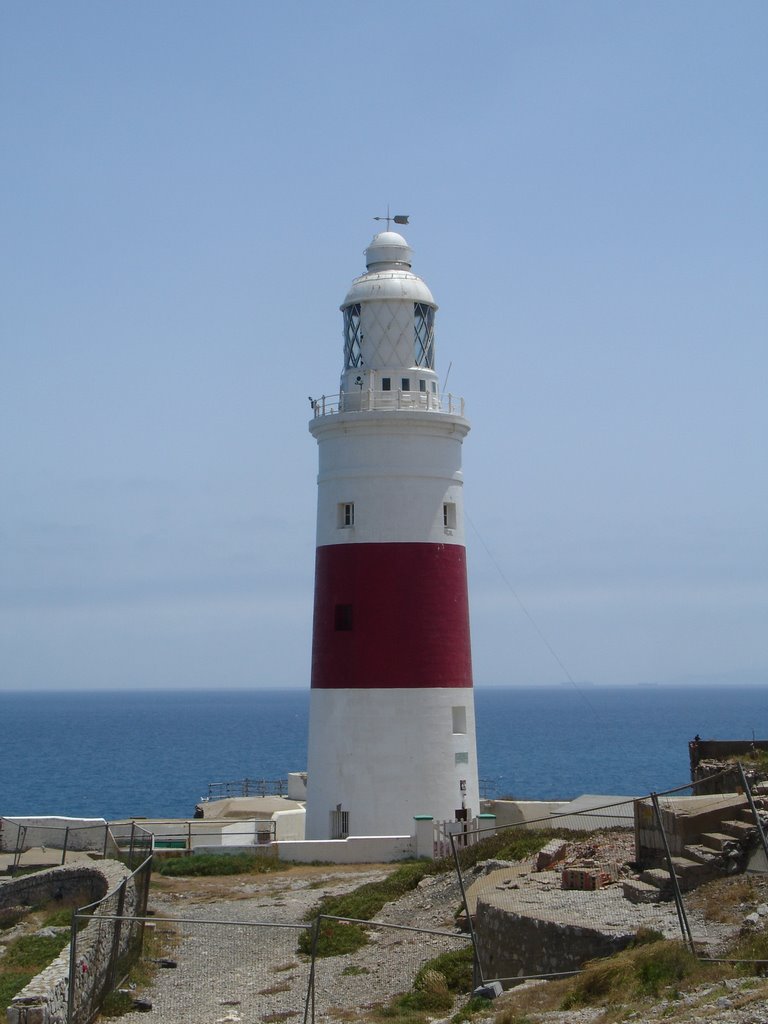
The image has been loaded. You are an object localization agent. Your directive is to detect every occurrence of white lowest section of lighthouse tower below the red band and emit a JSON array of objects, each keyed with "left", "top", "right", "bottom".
[{"left": 306, "top": 686, "right": 480, "bottom": 839}]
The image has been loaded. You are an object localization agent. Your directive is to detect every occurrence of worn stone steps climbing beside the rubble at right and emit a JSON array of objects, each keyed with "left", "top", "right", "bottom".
[{"left": 623, "top": 804, "right": 765, "bottom": 903}]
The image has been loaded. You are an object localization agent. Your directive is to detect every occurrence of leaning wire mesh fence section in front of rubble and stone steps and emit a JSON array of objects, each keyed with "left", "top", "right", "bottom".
[{"left": 451, "top": 779, "right": 768, "bottom": 983}]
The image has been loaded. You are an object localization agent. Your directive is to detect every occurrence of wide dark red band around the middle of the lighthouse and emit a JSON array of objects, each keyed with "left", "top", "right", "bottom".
[{"left": 312, "top": 544, "right": 472, "bottom": 689}]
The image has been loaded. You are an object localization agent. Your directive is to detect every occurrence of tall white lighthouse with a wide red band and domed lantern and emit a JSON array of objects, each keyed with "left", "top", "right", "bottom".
[{"left": 306, "top": 224, "right": 479, "bottom": 839}]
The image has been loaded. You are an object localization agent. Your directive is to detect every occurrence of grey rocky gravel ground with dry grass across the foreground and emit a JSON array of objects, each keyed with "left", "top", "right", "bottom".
[{"left": 105, "top": 865, "right": 768, "bottom": 1024}]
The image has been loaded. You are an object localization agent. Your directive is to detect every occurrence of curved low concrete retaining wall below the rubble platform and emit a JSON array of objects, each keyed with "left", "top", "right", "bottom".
[{"left": 475, "top": 899, "right": 634, "bottom": 987}]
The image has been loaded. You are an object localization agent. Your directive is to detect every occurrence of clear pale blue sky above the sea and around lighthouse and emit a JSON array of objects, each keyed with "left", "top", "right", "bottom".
[{"left": 0, "top": 0, "right": 768, "bottom": 688}]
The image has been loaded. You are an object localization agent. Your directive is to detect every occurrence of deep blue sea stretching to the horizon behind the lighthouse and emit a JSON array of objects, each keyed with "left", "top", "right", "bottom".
[{"left": 0, "top": 684, "right": 768, "bottom": 819}]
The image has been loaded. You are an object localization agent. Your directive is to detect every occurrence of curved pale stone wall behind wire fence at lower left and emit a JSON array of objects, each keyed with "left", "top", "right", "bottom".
[{"left": 0, "top": 860, "right": 145, "bottom": 1024}]
